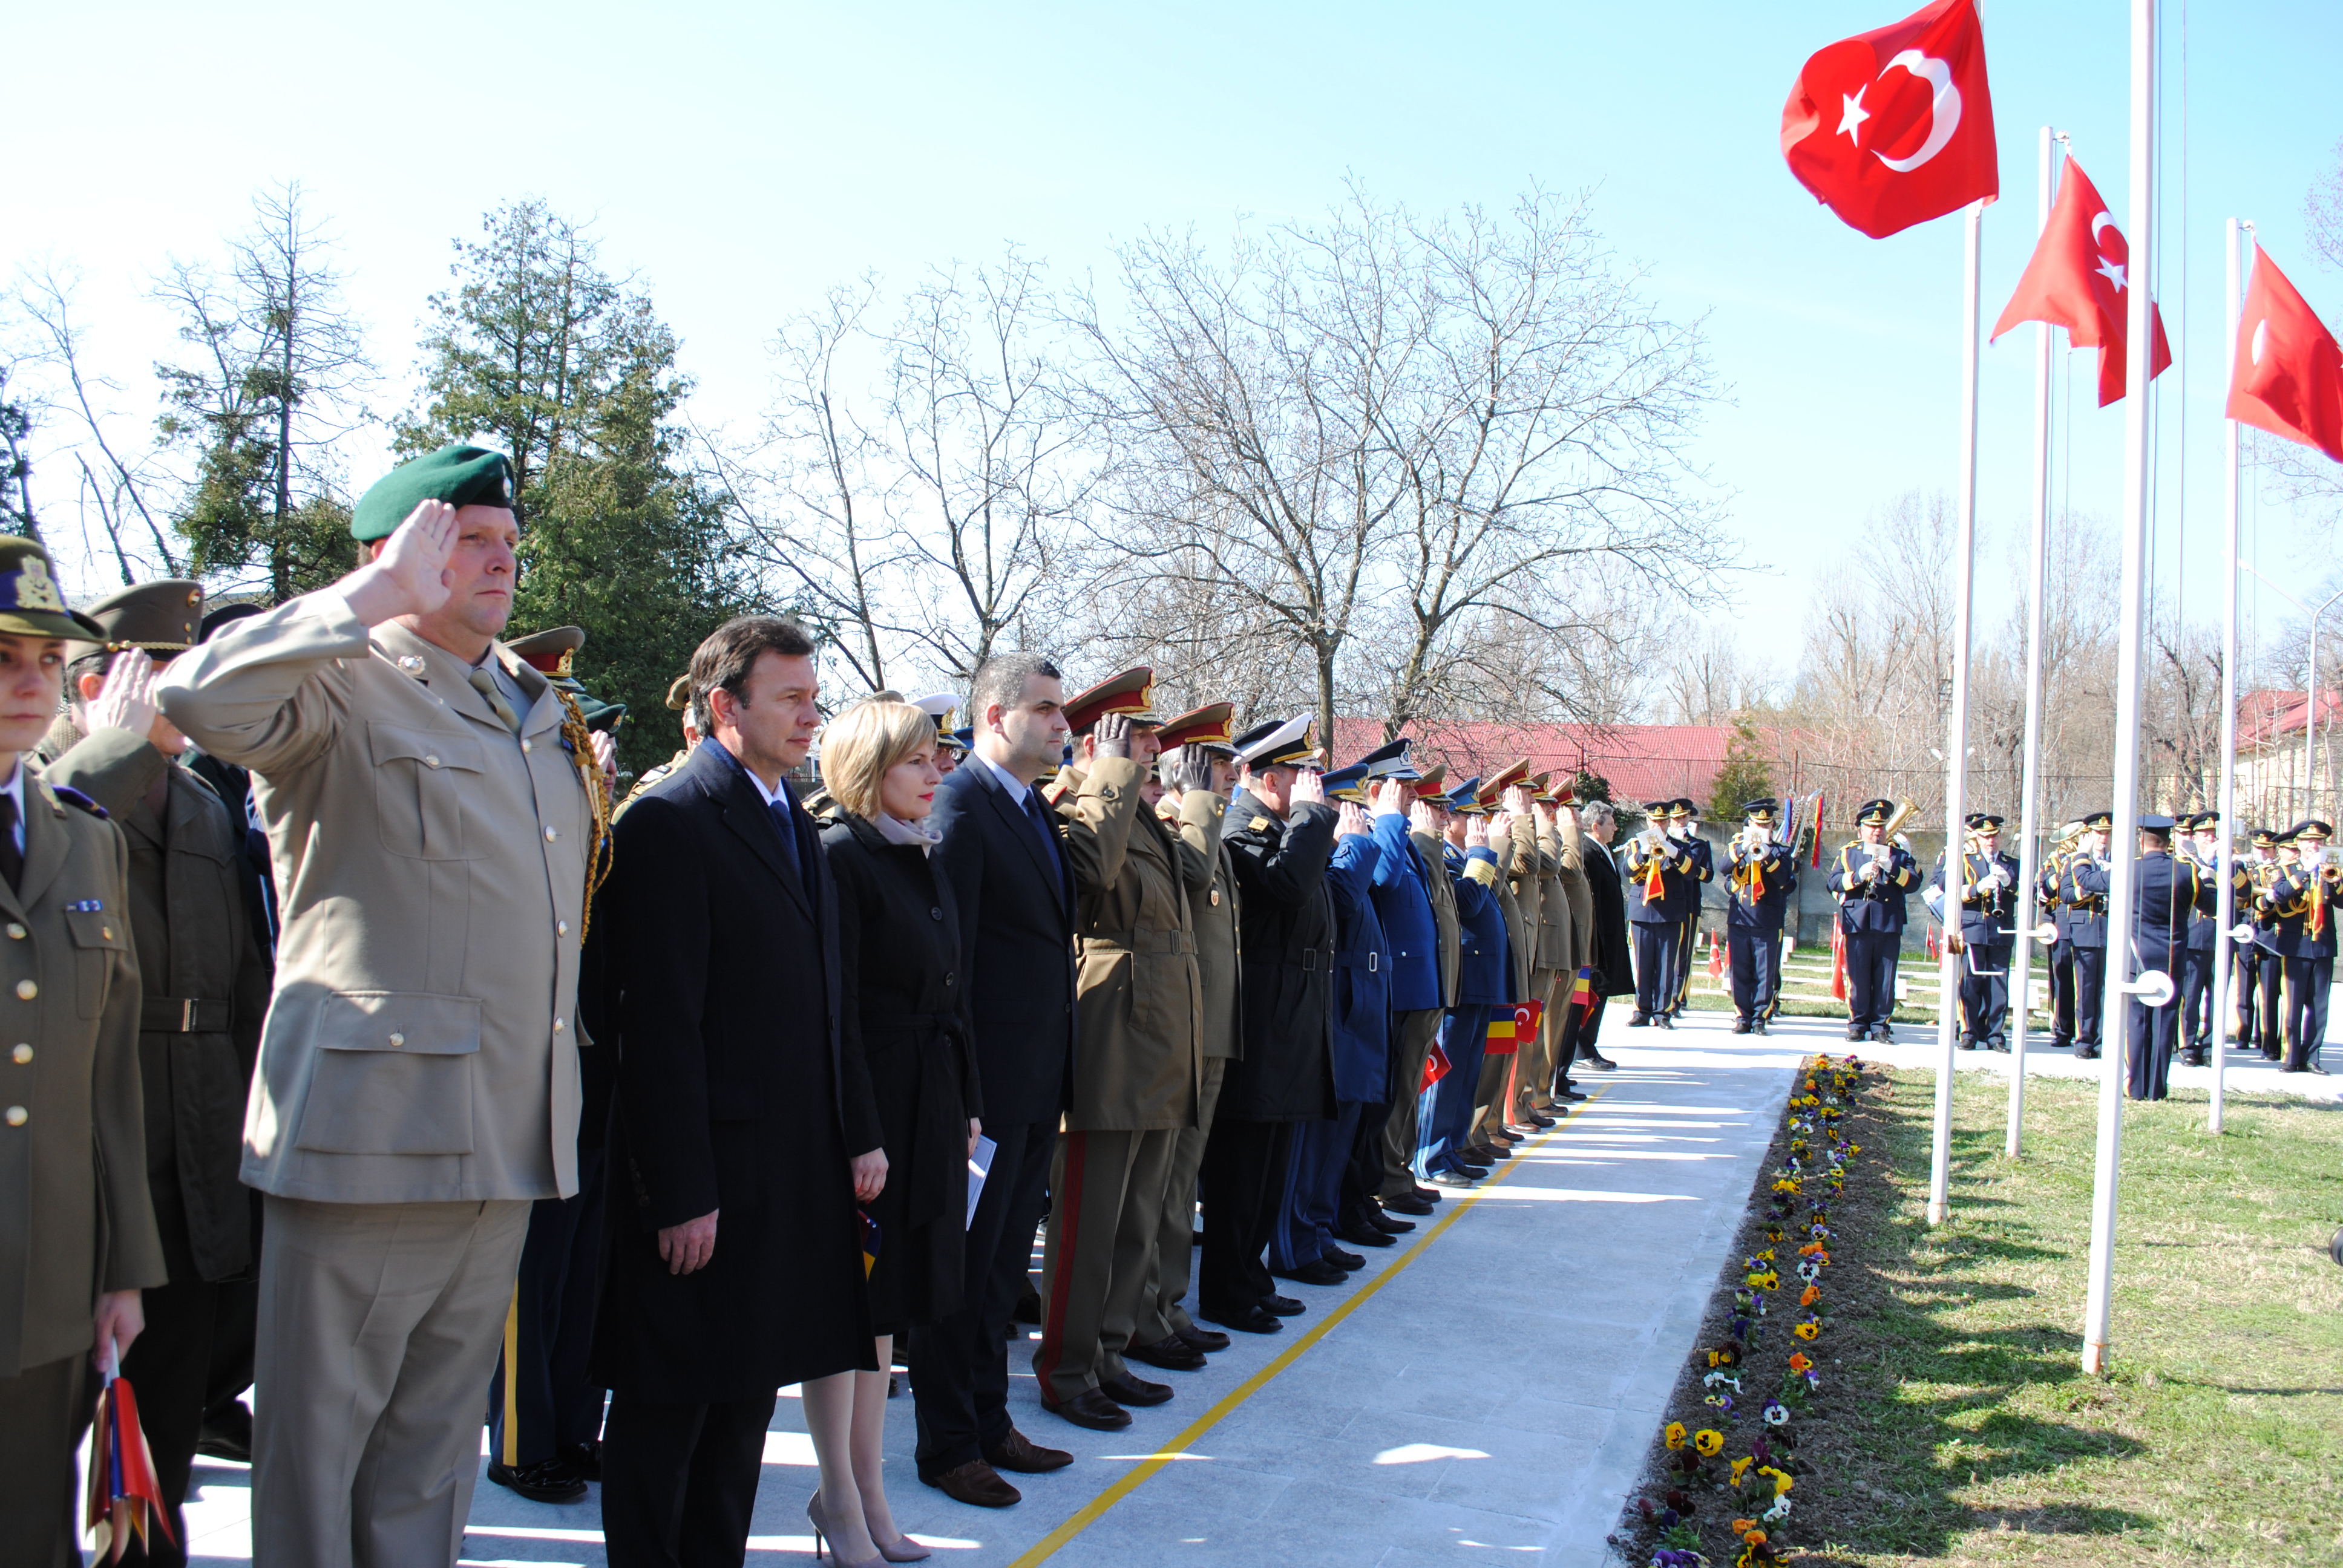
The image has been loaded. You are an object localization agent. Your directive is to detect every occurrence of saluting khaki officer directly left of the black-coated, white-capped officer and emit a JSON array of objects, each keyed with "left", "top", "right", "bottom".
[{"left": 1132, "top": 703, "right": 1244, "bottom": 1364}]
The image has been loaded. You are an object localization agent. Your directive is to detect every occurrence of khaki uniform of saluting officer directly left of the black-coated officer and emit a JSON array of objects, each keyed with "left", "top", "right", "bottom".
[{"left": 1132, "top": 790, "right": 1244, "bottom": 1345}]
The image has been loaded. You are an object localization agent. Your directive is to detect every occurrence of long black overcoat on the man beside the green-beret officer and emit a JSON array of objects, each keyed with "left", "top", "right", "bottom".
[{"left": 593, "top": 740, "right": 881, "bottom": 1404}]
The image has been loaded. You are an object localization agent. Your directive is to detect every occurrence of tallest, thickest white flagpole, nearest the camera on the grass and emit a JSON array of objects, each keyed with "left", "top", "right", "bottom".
[{"left": 2083, "top": 0, "right": 2155, "bottom": 1376}]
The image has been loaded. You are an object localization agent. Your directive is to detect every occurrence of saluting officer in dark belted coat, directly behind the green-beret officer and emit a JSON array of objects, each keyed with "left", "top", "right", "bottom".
[{"left": 40, "top": 579, "right": 269, "bottom": 1563}]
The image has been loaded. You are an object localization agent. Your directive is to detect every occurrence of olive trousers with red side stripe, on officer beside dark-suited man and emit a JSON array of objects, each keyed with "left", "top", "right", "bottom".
[{"left": 1035, "top": 1128, "right": 1181, "bottom": 1397}]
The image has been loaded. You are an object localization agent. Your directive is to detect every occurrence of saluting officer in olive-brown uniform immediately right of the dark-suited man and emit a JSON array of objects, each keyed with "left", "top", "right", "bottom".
[{"left": 1034, "top": 668, "right": 1221, "bottom": 1432}]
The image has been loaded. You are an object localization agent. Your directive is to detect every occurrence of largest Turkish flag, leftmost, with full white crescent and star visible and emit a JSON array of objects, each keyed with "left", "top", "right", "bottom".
[{"left": 1781, "top": 0, "right": 2001, "bottom": 239}]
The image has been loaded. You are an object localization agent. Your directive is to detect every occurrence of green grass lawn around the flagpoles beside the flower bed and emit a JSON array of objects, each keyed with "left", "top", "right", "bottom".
[{"left": 1761, "top": 1073, "right": 2343, "bottom": 1563}]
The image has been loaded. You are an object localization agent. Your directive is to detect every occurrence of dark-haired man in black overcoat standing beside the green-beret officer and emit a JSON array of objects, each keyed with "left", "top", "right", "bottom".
[{"left": 588, "top": 616, "right": 886, "bottom": 1566}]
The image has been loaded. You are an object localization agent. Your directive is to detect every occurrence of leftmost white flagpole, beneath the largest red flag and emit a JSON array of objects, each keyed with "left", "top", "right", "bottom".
[{"left": 1928, "top": 201, "right": 1985, "bottom": 1226}]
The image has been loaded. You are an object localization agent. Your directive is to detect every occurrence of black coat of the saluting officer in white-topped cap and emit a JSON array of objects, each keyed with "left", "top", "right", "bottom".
[{"left": 1214, "top": 792, "right": 1340, "bottom": 1123}]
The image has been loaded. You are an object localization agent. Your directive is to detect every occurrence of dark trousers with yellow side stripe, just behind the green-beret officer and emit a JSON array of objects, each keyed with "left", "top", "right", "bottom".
[{"left": 487, "top": 1148, "right": 605, "bottom": 1469}]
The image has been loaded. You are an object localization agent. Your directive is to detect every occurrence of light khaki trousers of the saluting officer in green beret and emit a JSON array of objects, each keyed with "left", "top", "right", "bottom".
[{"left": 253, "top": 1198, "right": 529, "bottom": 1568}]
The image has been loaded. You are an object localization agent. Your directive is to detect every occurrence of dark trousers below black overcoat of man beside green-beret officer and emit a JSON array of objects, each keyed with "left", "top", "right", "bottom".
[{"left": 602, "top": 1390, "right": 773, "bottom": 1568}]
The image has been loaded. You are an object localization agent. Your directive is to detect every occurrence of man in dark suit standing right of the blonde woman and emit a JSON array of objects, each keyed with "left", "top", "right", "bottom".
[{"left": 909, "top": 654, "right": 1075, "bottom": 1507}]
